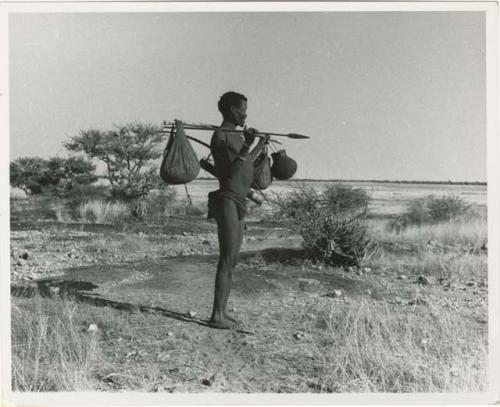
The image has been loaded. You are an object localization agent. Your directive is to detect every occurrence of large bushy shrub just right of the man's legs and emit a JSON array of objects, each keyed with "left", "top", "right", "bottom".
[{"left": 273, "top": 184, "right": 370, "bottom": 265}]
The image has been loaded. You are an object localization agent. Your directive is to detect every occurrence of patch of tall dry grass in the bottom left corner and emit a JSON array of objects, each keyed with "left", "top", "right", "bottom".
[{"left": 11, "top": 297, "right": 100, "bottom": 392}]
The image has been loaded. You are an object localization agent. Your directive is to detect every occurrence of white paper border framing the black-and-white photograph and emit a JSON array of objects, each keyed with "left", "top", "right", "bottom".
[{"left": 0, "top": 0, "right": 500, "bottom": 406}]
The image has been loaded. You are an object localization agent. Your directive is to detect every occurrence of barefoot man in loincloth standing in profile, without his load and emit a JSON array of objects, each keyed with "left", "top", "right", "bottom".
[{"left": 208, "top": 92, "right": 269, "bottom": 329}]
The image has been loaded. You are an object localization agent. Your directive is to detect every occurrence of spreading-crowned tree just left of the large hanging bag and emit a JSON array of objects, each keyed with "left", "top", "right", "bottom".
[{"left": 65, "top": 123, "right": 165, "bottom": 201}]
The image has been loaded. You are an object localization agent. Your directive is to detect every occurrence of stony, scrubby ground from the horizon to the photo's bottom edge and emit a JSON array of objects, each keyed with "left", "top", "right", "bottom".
[{"left": 11, "top": 181, "right": 488, "bottom": 393}]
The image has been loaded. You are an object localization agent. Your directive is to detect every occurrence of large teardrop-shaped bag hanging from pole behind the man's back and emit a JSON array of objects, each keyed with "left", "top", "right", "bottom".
[{"left": 160, "top": 120, "right": 200, "bottom": 185}]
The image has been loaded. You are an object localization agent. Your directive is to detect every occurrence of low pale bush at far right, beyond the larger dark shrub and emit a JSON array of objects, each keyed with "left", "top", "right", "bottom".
[{"left": 389, "top": 194, "right": 472, "bottom": 231}]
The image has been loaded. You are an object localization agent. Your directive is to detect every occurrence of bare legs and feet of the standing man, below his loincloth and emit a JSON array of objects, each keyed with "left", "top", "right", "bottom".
[{"left": 210, "top": 199, "right": 240, "bottom": 329}]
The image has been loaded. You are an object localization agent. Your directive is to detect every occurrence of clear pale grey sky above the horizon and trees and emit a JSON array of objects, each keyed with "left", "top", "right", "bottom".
[{"left": 9, "top": 11, "right": 486, "bottom": 181}]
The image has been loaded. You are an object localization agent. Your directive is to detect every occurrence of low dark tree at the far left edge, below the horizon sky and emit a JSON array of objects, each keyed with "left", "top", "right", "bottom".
[{"left": 10, "top": 157, "right": 97, "bottom": 194}]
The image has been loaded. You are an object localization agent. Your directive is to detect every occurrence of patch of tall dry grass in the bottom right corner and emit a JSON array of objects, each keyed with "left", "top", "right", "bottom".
[{"left": 317, "top": 301, "right": 487, "bottom": 392}]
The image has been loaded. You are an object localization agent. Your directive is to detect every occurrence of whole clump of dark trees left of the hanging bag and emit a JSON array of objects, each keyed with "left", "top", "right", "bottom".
[{"left": 10, "top": 123, "right": 166, "bottom": 201}]
